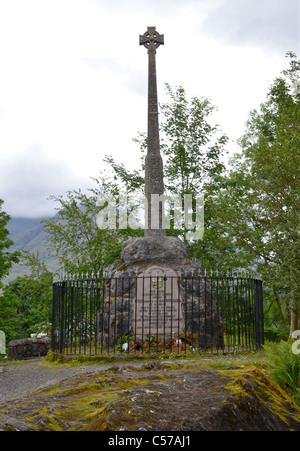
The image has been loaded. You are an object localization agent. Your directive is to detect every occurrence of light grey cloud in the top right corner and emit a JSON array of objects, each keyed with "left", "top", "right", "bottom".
[{"left": 201, "top": 0, "right": 300, "bottom": 53}]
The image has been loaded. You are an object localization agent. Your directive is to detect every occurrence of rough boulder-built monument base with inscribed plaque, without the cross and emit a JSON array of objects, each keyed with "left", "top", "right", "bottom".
[{"left": 99, "top": 237, "right": 223, "bottom": 348}]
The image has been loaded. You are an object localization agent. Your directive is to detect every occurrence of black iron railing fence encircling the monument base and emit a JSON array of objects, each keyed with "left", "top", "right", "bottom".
[{"left": 52, "top": 273, "right": 264, "bottom": 355}]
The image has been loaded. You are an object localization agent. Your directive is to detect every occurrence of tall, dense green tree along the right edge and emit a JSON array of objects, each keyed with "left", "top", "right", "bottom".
[{"left": 212, "top": 53, "right": 300, "bottom": 334}]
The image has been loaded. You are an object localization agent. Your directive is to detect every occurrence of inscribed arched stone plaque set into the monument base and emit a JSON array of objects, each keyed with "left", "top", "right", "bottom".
[{"left": 134, "top": 266, "right": 182, "bottom": 336}]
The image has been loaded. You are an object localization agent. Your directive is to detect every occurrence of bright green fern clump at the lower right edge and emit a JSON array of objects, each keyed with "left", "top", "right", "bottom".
[{"left": 264, "top": 341, "right": 300, "bottom": 406}]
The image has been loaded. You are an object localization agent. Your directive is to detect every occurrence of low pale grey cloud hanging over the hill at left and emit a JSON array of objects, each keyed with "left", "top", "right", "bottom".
[{"left": 0, "top": 144, "right": 88, "bottom": 218}]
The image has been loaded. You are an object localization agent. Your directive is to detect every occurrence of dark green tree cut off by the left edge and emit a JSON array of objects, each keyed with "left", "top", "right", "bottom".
[{"left": 0, "top": 199, "right": 20, "bottom": 287}]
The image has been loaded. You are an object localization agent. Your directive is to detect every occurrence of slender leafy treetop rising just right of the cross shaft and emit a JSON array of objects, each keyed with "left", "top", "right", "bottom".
[{"left": 160, "top": 84, "right": 228, "bottom": 195}]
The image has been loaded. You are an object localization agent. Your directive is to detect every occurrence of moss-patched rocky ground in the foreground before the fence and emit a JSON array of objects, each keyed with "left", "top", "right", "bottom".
[{"left": 0, "top": 359, "right": 300, "bottom": 431}]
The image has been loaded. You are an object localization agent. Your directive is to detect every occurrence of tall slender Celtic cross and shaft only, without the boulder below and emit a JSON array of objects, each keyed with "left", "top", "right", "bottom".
[{"left": 140, "top": 27, "right": 166, "bottom": 236}]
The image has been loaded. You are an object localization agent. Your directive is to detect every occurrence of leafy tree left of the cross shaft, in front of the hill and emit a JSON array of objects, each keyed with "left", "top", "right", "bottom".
[{"left": 43, "top": 174, "right": 141, "bottom": 275}]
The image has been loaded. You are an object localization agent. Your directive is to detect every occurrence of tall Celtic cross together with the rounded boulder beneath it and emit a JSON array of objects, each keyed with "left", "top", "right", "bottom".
[{"left": 122, "top": 27, "right": 187, "bottom": 266}]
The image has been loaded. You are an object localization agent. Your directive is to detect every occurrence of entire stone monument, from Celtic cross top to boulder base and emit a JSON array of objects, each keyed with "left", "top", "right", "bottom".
[{"left": 99, "top": 27, "right": 223, "bottom": 347}]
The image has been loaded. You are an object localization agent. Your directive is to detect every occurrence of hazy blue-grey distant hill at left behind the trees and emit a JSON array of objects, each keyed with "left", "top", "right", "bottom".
[{"left": 3, "top": 218, "right": 57, "bottom": 283}]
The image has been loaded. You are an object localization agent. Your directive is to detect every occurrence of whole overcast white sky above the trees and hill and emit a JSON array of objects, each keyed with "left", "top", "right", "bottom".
[{"left": 0, "top": 0, "right": 300, "bottom": 217}]
